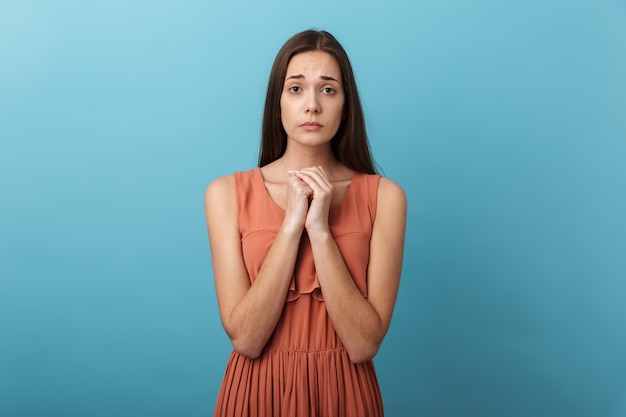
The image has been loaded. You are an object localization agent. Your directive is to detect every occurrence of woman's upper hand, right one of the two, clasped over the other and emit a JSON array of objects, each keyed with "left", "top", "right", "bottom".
[{"left": 296, "top": 167, "right": 333, "bottom": 235}]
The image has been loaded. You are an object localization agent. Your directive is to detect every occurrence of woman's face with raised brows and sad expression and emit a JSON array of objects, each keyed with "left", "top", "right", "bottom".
[{"left": 280, "top": 51, "right": 345, "bottom": 146}]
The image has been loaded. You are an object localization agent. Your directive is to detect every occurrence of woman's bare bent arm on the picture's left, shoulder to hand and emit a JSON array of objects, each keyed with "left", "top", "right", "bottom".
[{"left": 205, "top": 175, "right": 308, "bottom": 358}]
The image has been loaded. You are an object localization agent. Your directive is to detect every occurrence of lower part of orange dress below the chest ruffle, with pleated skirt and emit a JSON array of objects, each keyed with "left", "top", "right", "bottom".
[{"left": 214, "top": 294, "right": 383, "bottom": 417}]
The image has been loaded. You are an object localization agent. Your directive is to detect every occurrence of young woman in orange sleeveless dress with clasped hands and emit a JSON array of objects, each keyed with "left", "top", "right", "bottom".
[{"left": 205, "top": 31, "right": 406, "bottom": 417}]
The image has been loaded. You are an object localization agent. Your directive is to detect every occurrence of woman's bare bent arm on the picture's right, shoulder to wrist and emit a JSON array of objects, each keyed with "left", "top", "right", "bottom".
[{"left": 292, "top": 167, "right": 406, "bottom": 362}]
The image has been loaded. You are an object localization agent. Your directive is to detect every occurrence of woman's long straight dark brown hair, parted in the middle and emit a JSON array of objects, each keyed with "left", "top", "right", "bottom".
[{"left": 259, "top": 30, "right": 376, "bottom": 174}]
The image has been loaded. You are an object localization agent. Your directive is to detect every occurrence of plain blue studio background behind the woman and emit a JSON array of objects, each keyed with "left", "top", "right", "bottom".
[{"left": 0, "top": 0, "right": 626, "bottom": 417}]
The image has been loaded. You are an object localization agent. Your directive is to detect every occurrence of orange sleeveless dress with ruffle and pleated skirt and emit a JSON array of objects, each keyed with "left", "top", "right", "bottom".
[{"left": 214, "top": 168, "right": 383, "bottom": 417}]
